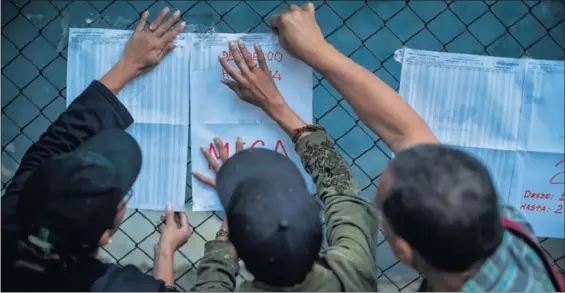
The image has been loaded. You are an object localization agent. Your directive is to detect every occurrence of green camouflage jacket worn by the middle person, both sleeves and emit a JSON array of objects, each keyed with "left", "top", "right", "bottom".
[{"left": 191, "top": 131, "right": 379, "bottom": 292}]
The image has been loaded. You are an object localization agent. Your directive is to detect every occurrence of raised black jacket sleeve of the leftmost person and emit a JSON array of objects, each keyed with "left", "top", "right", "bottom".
[{"left": 2, "top": 81, "right": 133, "bottom": 230}]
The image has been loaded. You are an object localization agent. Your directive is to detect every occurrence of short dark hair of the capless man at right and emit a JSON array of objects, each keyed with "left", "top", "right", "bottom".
[{"left": 382, "top": 144, "right": 503, "bottom": 272}]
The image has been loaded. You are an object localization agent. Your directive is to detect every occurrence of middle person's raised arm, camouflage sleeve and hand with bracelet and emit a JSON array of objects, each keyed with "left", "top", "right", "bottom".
[{"left": 216, "top": 43, "right": 379, "bottom": 291}]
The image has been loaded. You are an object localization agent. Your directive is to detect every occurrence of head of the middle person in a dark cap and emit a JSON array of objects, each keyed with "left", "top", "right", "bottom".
[{"left": 216, "top": 149, "right": 322, "bottom": 287}]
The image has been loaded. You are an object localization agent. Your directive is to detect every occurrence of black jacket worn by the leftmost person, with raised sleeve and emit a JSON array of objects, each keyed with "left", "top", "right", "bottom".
[{"left": 1, "top": 81, "right": 176, "bottom": 292}]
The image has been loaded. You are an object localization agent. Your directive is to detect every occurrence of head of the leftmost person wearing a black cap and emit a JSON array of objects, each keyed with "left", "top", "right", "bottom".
[{"left": 17, "top": 129, "right": 141, "bottom": 259}]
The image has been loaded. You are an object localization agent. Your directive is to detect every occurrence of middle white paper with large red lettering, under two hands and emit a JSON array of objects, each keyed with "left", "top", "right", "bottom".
[{"left": 190, "top": 34, "right": 313, "bottom": 211}]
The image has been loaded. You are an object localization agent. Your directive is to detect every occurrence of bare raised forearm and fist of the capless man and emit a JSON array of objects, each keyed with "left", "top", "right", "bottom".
[{"left": 271, "top": 3, "right": 437, "bottom": 152}]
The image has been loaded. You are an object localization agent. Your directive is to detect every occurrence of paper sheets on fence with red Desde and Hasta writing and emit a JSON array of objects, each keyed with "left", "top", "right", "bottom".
[{"left": 400, "top": 49, "right": 565, "bottom": 238}]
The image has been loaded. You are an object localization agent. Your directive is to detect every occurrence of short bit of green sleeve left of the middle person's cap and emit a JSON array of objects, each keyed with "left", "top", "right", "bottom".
[{"left": 190, "top": 240, "right": 239, "bottom": 292}]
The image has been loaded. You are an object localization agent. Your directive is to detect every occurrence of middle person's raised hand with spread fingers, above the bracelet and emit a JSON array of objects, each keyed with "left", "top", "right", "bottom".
[{"left": 220, "top": 41, "right": 286, "bottom": 115}]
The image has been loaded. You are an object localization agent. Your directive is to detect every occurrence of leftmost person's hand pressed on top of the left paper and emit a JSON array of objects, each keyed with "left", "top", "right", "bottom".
[{"left": 121, "top": 8, "right": 186, "bottom": 75}]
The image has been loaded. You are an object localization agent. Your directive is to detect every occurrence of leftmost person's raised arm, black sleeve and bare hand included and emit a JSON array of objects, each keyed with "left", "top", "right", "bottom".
[{"left": 2, "top": 8, "right": 184, "bottom": 229}]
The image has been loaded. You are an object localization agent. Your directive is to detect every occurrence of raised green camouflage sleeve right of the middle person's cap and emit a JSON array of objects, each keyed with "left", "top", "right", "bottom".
[{"left": 296, "top": 131, "right": 379, "bottom": 291}]
